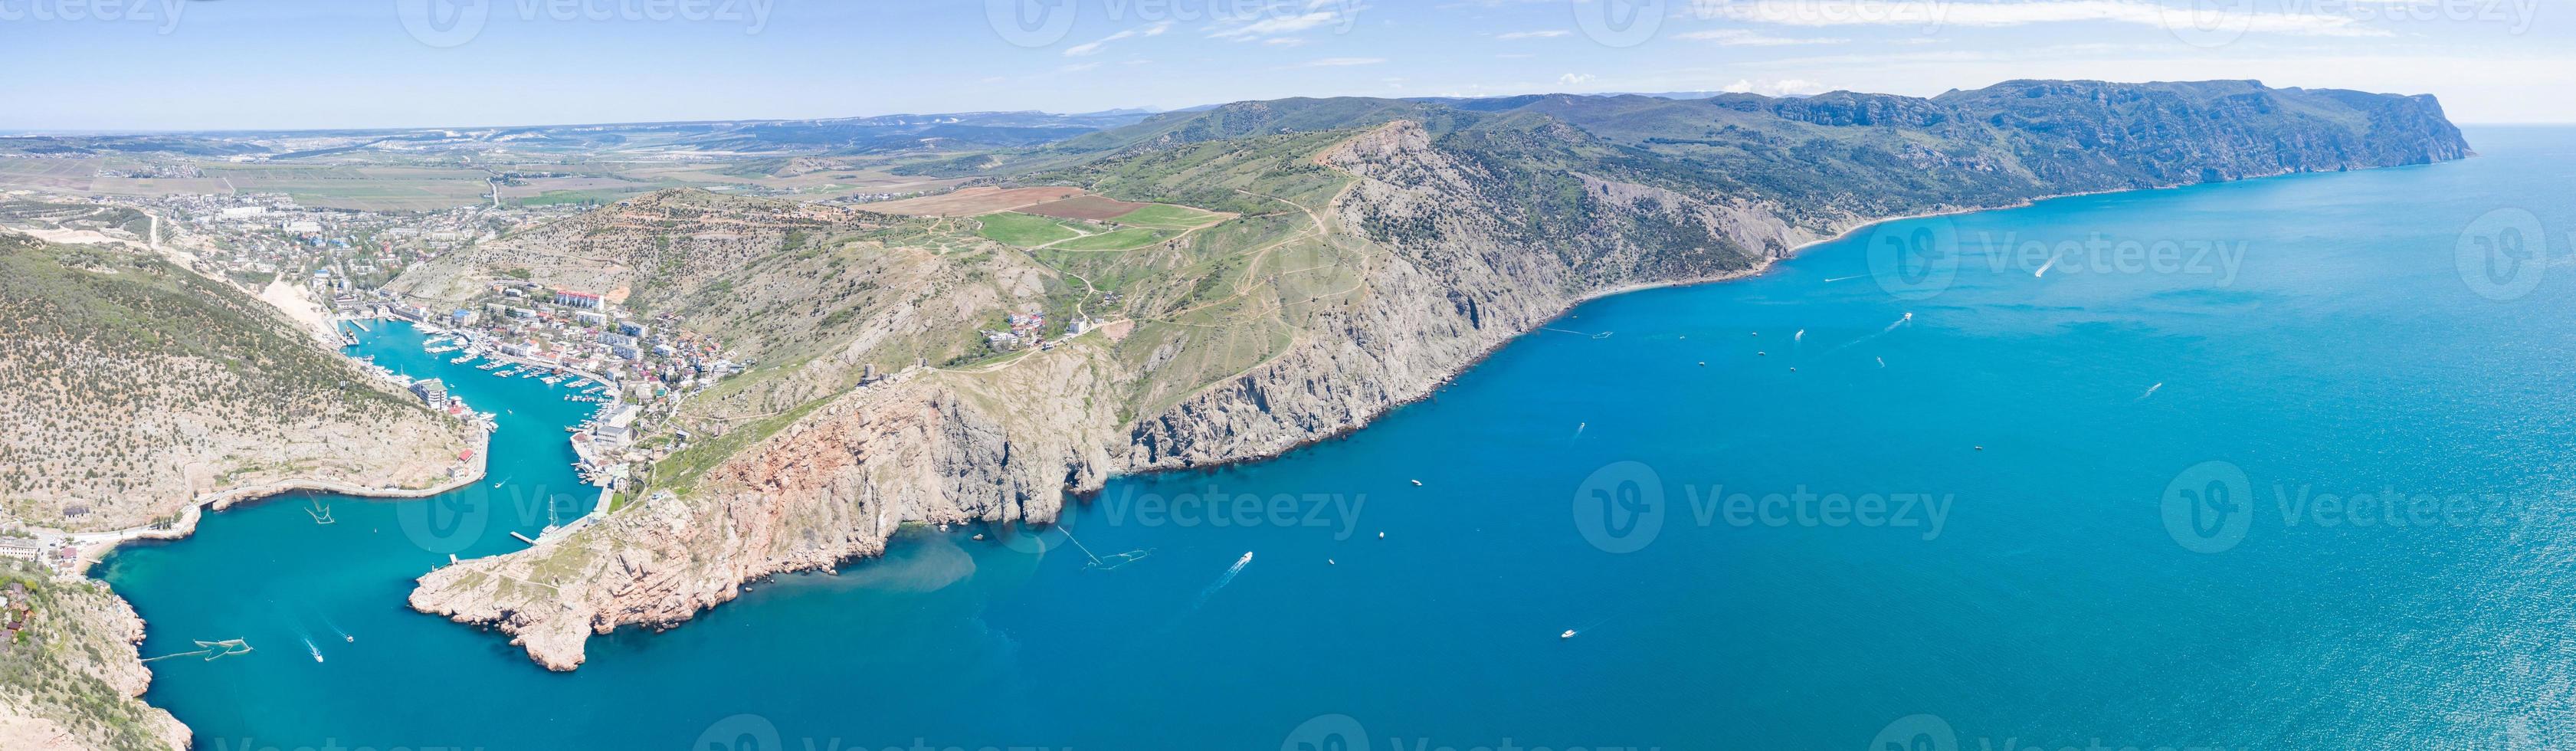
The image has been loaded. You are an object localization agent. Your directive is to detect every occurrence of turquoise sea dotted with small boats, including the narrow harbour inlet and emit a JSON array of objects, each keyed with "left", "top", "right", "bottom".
[{"left": 98, "top": 129, "right": 2576, "bottom": 751}]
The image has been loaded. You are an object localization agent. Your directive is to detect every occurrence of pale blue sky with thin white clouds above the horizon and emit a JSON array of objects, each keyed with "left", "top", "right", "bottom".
[{"left": 0, "top": 0, "right": 2576, "bottom": 132}]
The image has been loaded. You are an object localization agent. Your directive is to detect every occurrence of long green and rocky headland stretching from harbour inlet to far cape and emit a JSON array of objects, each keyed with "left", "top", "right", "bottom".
[{"left": 397, "top": 83, "right": 2468, "bottom": 668}]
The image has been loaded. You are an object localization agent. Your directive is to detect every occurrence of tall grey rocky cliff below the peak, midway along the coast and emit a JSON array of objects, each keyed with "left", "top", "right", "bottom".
[{"left": 1123, "top": 121, "right": 1819, "bottom": 470}]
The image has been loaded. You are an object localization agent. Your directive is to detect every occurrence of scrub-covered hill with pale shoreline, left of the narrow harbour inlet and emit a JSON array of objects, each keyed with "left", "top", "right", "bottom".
[{"left": 0, "top": 234, "right": 474, "bottom": 532}]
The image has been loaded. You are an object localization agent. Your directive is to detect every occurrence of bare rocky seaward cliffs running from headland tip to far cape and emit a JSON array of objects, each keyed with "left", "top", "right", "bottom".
[{"left": 410, "top": 83, "right": 2465, "bottom": 671}]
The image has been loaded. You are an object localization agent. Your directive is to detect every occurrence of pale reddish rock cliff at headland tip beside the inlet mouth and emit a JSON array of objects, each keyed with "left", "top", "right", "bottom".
[{"left": 412, "top": 341, "right": 1116, "bottom": 671}]
